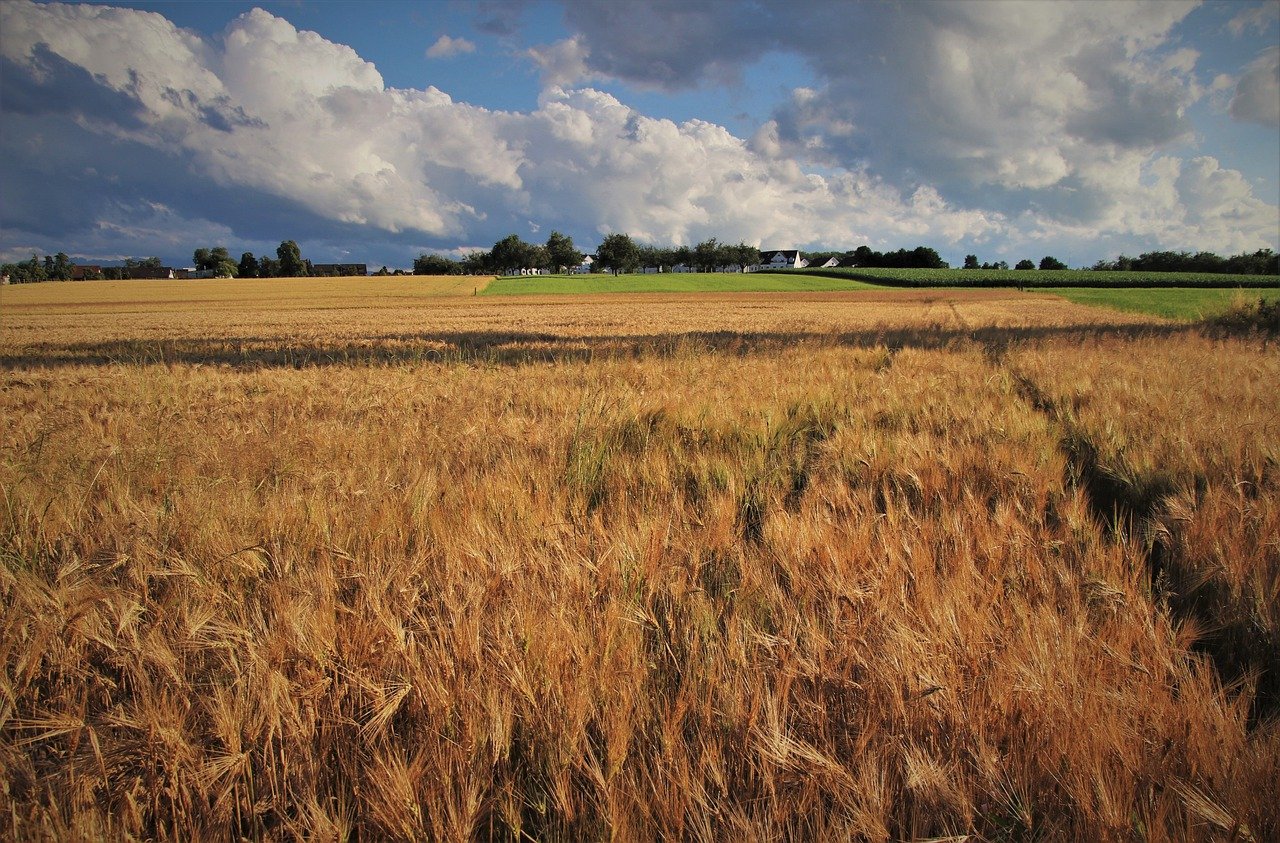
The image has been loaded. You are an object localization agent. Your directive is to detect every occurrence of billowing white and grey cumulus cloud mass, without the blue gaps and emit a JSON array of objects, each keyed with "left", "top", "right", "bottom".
[{"left": 0, "top": 0, "right": 1277, "bottom": 263}]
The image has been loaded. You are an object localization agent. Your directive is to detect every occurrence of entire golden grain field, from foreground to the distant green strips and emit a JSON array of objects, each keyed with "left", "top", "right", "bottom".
[{"left": 0, "top": 279, "right": 1280, "bottom": 840}]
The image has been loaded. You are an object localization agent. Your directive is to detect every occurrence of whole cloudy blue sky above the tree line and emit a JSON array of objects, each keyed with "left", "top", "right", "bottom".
[{"left": 0, "top": 0, "right": 1280, "bottom": 269}]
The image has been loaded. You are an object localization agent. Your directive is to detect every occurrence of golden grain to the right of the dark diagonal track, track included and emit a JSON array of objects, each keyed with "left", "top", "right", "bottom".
[{"left": 1015, "top": 338, "right": 1280, "bottom": 713}]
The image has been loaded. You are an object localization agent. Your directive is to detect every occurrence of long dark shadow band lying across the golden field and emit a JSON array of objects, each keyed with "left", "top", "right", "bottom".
[{"left": 0, "top": 324, "right": 1198, "bottom": 370}]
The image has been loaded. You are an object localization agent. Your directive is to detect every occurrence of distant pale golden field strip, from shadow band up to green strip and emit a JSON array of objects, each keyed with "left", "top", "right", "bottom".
[{"left": 0, "top": 278, "right": 1160, "bottom": 365}]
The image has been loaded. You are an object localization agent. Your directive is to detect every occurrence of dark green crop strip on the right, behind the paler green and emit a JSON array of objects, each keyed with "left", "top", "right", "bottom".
[{"left": 791, "top": 267, "right": 1280, "bottom": 289}]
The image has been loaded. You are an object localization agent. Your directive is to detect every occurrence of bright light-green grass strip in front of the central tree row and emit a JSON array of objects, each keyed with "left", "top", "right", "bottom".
[{"left": 480, "top": 272, "right": 874, "bottom": 295}]
